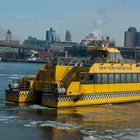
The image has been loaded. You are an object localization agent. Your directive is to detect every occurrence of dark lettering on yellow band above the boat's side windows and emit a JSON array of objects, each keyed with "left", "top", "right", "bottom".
[{"left": 99, "top": 66, "right": 133, "bottom": 70}]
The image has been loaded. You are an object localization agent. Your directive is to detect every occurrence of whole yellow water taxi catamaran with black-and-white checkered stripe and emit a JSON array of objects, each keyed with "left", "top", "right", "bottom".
[{"left": 6, "top": 42, "right": 140, "bottom": 107}]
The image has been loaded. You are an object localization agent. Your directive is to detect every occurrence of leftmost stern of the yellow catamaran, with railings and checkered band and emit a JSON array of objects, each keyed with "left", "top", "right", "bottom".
[{"left": 5, "top": 79, "right": 37, "bottom": 103}]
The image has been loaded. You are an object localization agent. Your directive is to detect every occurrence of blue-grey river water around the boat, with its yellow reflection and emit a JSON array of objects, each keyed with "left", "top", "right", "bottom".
[{"left": 0, "top": 63, "right": 140, "bottom": 140}]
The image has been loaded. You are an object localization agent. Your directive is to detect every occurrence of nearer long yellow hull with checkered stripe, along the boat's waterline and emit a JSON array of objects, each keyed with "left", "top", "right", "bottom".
[{"left": 42, "top": 91, "right": 140, "bottom": 107}]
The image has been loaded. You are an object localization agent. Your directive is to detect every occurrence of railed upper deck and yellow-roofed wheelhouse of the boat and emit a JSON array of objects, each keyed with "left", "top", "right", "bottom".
[{"left": 47, "top": 46, "right": 136, "bottom": 66}]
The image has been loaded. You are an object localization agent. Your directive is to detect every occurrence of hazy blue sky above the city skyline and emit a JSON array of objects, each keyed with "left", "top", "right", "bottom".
[{"left": 0, "top": 0, "right": 140, "bottom": 46}]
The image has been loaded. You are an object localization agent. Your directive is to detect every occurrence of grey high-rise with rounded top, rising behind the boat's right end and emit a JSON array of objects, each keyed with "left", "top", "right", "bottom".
[{"left": 124, "top": 27, "right": 137, "bottom": 47}]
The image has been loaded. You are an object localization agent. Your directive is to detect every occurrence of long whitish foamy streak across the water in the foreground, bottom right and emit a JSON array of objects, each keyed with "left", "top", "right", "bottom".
[{"left": 24, "top": 121, "right": 140, "bottom": 140}]
